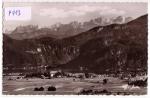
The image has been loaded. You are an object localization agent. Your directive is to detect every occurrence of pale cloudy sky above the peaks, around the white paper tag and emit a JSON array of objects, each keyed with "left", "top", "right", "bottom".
[{"left": 3, "top": 2, "right": 148, "bottom": 30}]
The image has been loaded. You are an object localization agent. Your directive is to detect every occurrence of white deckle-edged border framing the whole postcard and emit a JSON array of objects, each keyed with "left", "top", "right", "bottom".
[{"left": 0, "top": 0, "right": 150, "bottom": 98}]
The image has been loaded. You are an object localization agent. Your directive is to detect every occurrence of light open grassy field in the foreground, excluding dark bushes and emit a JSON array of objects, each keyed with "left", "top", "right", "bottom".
[{"left": 3, "top": 77, "right": 147, "bottom": 95}]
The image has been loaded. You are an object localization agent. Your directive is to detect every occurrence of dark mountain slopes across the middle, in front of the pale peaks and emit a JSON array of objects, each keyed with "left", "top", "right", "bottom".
[{"left": 3, "top": 15, "right": 148, "bottom": 73}]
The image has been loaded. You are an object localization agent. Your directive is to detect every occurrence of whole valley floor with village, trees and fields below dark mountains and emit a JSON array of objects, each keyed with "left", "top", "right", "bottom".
[{"left": 3, "top": 66, "right": 147, "bottom": 95}]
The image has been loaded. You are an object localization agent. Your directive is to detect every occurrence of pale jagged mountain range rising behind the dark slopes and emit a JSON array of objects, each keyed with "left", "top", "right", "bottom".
[{"left": 6, "top": 16, "right": 132, "bottom": 40}]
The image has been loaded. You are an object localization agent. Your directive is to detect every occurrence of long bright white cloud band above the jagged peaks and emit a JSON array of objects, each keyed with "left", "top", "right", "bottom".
[{"left": 40, "top": 5, "right": 125, "bottom": 18}]
